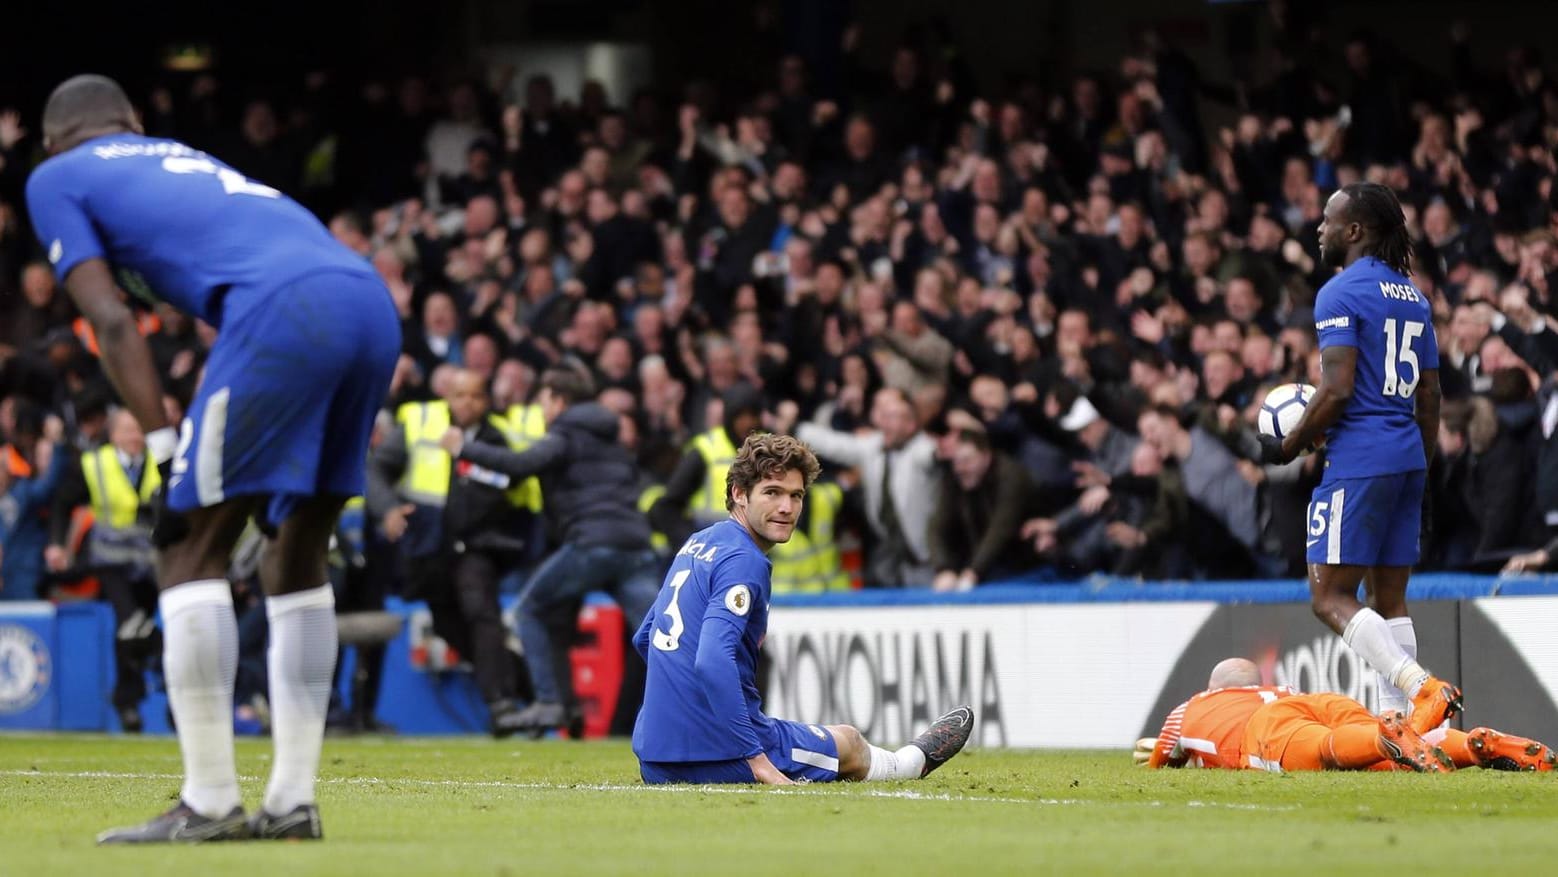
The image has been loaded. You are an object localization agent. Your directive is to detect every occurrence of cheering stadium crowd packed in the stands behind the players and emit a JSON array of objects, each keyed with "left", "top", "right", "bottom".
[{"left": 9, "top": 17, "right": 1558, "bottom": 632}]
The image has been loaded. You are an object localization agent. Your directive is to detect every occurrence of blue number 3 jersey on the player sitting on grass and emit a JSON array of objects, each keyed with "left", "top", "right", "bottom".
[{"left": 633, "top": 520, "right": 773, "bottom": 762}]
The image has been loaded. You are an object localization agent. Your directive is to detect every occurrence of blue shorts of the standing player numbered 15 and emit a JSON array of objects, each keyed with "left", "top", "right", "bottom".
[{"left": 1304, "top": 469, "right": 1426, "bottom": 567}]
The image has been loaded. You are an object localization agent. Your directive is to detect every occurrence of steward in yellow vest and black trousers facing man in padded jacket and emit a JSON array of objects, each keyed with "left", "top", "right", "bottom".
[{"left": 368, "top": 369, "right": 533, "bottom": 737}]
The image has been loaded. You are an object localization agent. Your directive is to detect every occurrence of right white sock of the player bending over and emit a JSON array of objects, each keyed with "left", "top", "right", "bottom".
[{"left": 265, "top": 584, "right": 337, "bottom": 816}]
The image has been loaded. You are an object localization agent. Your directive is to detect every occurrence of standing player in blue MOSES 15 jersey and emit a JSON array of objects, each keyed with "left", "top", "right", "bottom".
[{"left": 1260, "top": 182, "right": 1461, "bottom": 734}]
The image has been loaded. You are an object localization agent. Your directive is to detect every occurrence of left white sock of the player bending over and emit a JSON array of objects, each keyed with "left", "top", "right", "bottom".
[{"left": 157, "top": 579, "right": 241, "bottom": 818}]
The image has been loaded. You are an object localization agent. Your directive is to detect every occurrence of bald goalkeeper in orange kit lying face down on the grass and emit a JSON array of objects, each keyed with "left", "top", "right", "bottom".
[{"left": 1136, "top": 657, "right": 1555, "bottom": 773}]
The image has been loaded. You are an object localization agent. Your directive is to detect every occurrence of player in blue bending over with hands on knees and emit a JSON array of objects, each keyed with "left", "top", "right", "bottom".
[{"left": 26, "top": 76, "right": 400, "bottom": 843}]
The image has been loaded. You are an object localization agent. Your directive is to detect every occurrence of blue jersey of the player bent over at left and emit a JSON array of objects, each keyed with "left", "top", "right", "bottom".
[{"left": 26, "top": 134, "right": 372, "bottom": 324}]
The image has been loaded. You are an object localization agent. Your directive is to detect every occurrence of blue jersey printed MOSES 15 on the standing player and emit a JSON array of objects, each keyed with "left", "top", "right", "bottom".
[{"left": 1315, "top": 257, "right": 1440, "bottom": 478}]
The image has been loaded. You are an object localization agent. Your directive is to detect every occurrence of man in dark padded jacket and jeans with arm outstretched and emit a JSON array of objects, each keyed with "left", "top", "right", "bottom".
[{"left": 442, "top": 368, "right": 661, "bottom": 735}]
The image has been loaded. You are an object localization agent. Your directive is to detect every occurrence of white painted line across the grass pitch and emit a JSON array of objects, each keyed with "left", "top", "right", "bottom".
[{"left": 0, "top": 770, "right": 1298, "bottom": 813}]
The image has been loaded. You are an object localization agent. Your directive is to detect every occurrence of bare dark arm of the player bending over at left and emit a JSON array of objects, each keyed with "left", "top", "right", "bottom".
[{"left": 65, "top": 259, "right": 168, "bottom": 433}]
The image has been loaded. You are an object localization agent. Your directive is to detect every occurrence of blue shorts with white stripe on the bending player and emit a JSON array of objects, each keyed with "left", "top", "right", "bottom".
[{"left": 168, "top": 271, "right": 400, "bottom": 523}]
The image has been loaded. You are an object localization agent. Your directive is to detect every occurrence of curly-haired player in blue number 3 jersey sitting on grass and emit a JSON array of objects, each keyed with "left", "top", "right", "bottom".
[{"left": 633, "top": 433, "right": 974, "bottom": 785}]
